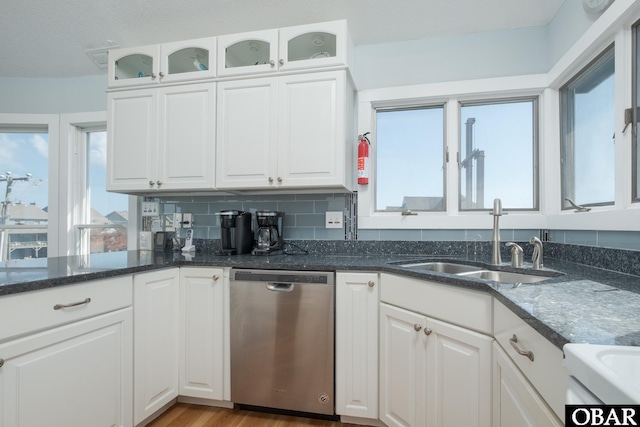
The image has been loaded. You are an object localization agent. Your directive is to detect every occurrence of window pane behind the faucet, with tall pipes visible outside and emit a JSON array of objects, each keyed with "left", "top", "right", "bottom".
[{"left": 460, "top": 99, "right": 538, "bottom": 210}]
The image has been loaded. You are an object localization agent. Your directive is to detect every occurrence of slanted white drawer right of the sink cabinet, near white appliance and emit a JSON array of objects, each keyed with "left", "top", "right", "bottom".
[{"left": 493, "top": 301, "right": 567, "bottom": 419}]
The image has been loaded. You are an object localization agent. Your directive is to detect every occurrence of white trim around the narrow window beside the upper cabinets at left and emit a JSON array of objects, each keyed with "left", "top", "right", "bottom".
[{"left": 57, "top": 111, "right": 139, "bottom": 255}]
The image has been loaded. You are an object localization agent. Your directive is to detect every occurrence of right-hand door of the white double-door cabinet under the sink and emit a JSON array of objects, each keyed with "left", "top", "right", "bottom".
[{"left": 425, "top": 318, "right": 492, "bottom": 427}]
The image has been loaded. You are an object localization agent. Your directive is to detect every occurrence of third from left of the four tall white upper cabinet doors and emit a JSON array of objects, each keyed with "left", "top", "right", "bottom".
[{"left": 216, "top": 78, "right": 277, "bottom": 188}]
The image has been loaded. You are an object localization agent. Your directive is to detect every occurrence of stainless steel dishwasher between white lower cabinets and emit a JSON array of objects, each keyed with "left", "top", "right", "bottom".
[{"left": 230, "top": 269, "right": 335, "bottom": 415}]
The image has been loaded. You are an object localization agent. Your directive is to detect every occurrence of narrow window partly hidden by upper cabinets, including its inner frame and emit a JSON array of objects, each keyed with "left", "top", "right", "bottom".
[{"left": 76, "top": 128, "right": 128, "bottom": 254}]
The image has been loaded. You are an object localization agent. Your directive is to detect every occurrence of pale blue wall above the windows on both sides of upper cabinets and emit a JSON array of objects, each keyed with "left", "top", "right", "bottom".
[{"left": 0, "top": 0, "right": 595, "bottom": 114}]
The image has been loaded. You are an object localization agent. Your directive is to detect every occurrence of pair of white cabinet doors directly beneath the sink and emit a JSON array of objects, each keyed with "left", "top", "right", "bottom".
[{"left": 380, "top": 303, "right": 493, "bottom": 427}]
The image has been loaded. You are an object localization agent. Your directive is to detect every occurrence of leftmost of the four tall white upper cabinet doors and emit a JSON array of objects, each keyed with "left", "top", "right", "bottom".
[{"left": 107, "top": 89, "right": 158, "bottom": 192}]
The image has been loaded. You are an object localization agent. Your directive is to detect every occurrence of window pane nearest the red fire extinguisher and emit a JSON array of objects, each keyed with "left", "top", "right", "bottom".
[{"left": 375, "top": 106, "right": 444, "bottom": 211}]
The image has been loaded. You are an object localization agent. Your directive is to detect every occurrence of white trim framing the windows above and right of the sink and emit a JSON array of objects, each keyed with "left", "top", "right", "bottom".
[{"left": 357, "top": 0, "right": 640, "bottom": 231}]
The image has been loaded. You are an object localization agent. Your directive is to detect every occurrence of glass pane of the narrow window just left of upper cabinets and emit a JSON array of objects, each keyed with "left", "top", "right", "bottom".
[{"left": 83, "top": 132, "right": 129, "bottom": 253}]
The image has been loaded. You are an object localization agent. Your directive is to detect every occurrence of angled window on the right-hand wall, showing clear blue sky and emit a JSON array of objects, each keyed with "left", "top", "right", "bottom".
[{"left": 560, "top": 46, "right": 615, "bottom": 209}]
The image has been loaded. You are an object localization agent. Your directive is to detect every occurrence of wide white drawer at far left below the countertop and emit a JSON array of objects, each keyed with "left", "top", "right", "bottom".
[{"left": 0, "top": 275, "right": 133, "bottom": 342}]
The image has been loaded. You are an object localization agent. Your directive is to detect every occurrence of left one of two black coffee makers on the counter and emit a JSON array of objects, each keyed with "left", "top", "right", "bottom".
[{"left": 217, "top": 210, "right": 253, "bottom": 255}]
